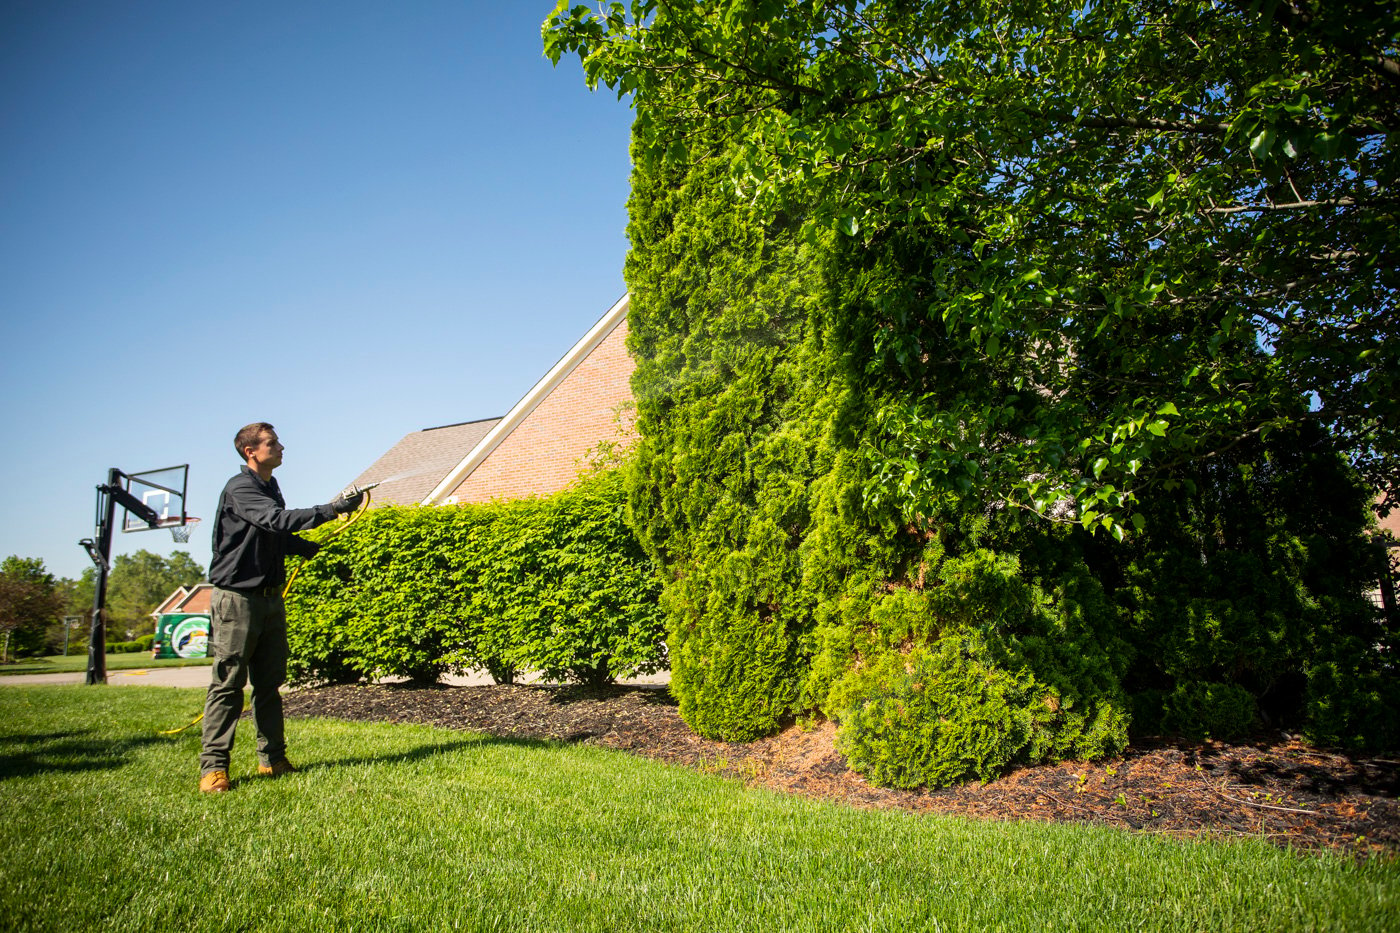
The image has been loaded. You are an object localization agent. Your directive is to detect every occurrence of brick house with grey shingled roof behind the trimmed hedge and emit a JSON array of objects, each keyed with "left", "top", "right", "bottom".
[{"left": 354, "top": 296, "right": 636, "bottom": 506}]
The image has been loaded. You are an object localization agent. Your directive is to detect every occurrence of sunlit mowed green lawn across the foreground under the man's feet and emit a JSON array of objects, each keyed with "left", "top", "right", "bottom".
[{"left": 0, "top": 685, "right": 1400, "bottom": 933}]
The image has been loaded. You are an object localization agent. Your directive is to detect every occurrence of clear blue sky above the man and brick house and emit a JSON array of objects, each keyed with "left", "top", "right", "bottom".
[{"left": 0, "top": 0, "right": 631, "bottom": 577}]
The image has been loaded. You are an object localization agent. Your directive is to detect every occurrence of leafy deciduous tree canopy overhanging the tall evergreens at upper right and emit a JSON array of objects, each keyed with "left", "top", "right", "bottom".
[{"left": 545, "top": 0, "right": 1400, "bottom": 537}]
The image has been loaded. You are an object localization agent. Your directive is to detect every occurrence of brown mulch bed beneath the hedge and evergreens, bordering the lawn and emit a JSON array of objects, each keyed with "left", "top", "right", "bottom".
[{"left": 284, "top": 684, "right": 1400, "bottom": 857}]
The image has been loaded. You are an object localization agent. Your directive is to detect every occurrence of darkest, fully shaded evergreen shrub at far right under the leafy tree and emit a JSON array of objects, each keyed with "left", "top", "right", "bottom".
[{"left": 1093, "top": 431, "right": 1400, "bottom": 749}]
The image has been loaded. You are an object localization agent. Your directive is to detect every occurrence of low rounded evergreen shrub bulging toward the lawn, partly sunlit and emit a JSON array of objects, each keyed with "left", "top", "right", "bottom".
[{"left": 826, "top": 549, "right": 1128, "bottom": 787}]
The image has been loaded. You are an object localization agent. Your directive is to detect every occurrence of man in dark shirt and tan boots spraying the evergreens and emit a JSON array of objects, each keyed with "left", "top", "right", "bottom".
[{"left": 199, "top": 422, "right": 364, "bottom": 793}]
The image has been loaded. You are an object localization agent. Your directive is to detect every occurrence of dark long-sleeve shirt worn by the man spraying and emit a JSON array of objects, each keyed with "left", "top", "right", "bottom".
[{"left": 209, "top": 467, "right": 336, "bottom": 590}]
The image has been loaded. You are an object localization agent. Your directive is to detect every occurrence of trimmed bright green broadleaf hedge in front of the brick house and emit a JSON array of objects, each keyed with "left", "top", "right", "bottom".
[{"left": 287, "top": 472, "right": 666, "bottom": 684}]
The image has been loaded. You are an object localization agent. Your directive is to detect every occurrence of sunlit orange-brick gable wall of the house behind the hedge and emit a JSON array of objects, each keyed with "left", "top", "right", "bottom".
[{"left": 448, "top": 319, "right": 637, "bottom": 502}]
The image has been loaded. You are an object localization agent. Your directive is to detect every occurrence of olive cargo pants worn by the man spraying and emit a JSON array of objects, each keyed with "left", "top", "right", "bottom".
[{"left": 199, "top": 587, "right": 287, "bottom": 775}]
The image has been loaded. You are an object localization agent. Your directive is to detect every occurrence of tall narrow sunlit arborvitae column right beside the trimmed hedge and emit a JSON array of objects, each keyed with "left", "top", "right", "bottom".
[{"left": 627, "top": 140, "right": 819, "bottom": 741}]
